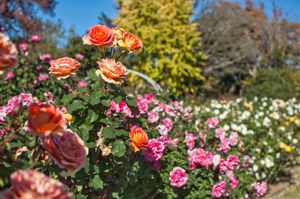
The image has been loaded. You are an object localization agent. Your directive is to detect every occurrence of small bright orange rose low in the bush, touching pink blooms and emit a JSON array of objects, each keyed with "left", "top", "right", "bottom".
[{"left": 129, "top": 126, "right": 148, "bottom": 152}]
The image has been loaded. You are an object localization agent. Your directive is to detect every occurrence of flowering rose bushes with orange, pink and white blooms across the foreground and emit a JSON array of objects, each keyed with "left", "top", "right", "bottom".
[{"left": 0, "top": 25, "right": 300, "bottom": 198}]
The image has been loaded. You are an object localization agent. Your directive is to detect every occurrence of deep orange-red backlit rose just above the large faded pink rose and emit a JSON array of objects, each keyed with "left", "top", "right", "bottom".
[{"left": 28, "top": 103, "right": 67, "bottom": 136}]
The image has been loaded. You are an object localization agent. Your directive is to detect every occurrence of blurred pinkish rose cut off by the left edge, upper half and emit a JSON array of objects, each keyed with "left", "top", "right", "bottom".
[{"left": 0, "top": 33, "right": 18, "bottom": 70}]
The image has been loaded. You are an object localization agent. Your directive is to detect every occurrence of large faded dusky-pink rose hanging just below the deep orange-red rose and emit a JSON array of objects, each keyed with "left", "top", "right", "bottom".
[{"left": 44, "top": 128, "right": 88, "bottom": 172}]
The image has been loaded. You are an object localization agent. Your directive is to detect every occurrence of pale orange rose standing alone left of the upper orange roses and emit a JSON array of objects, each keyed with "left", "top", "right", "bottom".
[{"left": 49, "top": 57, "right": 80, "bottom": 79}]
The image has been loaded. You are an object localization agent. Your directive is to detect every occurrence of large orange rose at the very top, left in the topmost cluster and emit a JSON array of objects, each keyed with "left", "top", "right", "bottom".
[{"left": 82, "top": 25, "right": 114, "bottom": 47}]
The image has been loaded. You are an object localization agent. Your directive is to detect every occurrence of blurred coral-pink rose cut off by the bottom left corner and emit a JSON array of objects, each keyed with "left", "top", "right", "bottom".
[{"left": 0, "top": 170, "right": 72, "bottom": 199}]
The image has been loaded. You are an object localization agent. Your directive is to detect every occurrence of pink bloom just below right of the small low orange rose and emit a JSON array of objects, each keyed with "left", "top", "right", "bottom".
[{"left": 144, "top": 139, "right": 165, "bottom": 162}]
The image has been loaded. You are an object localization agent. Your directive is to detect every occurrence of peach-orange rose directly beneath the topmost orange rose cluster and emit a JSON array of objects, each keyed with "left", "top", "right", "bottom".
[{"left": 96, "top": 59, "right": 127, "bottom": 84}]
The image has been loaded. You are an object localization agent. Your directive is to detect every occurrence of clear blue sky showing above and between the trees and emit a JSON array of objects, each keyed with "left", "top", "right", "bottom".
[{"left": 49, "top": 0, "right": 300, "bottom": 35}]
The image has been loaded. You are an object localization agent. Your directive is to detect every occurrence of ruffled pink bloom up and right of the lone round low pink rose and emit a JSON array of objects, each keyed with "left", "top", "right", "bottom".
[{"left": 188, "top": 148, "right": 214, "bottom": 170}]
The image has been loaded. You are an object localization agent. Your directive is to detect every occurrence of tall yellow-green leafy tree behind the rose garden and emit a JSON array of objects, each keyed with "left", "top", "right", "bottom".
[{"left": 115, "top": 0, "right": 206, "bottom": 93}]
